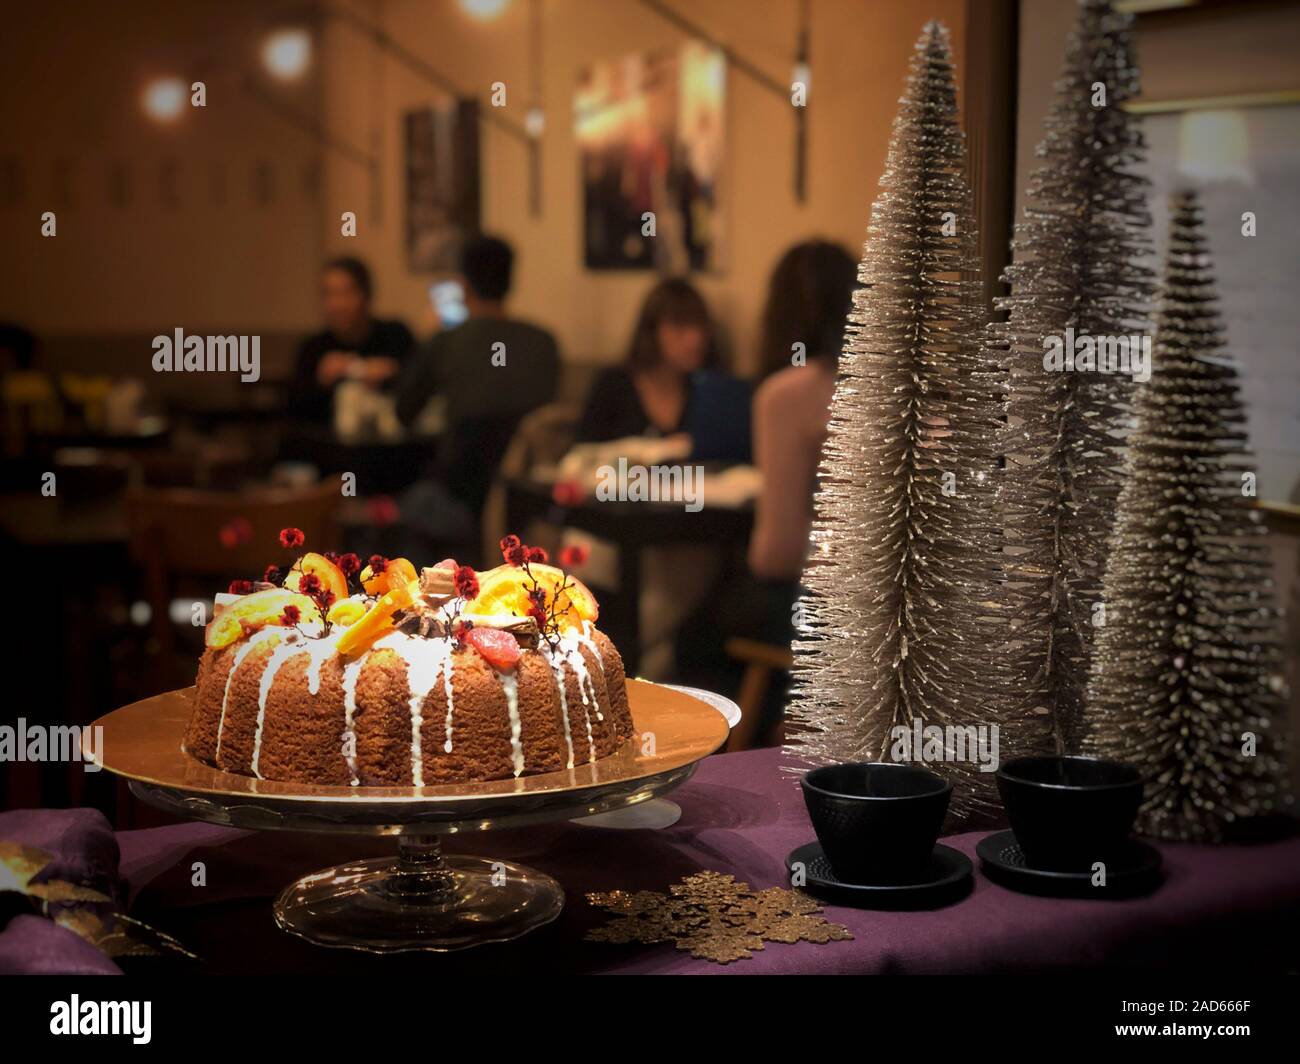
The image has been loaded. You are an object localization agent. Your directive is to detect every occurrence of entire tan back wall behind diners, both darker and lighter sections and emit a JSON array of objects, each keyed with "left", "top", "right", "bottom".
[{"left": 0, "top": 0, "right": 966, "bottom": 372}]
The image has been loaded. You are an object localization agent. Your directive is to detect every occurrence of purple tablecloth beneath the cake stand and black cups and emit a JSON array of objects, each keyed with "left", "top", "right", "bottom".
[{"left": 43, "top": 749, "right": 1300, "bottom": 974}]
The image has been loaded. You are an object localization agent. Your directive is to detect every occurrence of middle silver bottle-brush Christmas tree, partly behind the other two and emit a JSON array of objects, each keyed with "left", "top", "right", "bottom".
[{"left": 989, "top": 0, "right": 1152, "bottom": 752}]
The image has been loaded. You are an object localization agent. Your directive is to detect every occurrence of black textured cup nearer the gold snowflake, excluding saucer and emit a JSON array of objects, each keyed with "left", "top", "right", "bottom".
[{"left": 801, "top": 761, "right": 953, "bottom": 884}]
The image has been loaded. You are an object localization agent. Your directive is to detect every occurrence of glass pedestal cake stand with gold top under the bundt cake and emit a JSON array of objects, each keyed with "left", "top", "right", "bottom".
[{"left": 83, "top": 680, "right": 728, "bottom": 953}]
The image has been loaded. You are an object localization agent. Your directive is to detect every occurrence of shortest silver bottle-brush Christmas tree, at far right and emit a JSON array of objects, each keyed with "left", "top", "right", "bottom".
[{"left": 1084, "top": 193, "right": 1286, "bottom": 840}]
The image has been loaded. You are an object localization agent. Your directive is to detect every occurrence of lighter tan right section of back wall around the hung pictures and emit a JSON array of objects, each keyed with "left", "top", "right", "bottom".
[{"left": 324, "top": 0, "right": 966, "bottom": 369}]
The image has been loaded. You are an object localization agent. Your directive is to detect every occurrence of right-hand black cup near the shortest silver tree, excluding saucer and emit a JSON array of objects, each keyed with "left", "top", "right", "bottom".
[{"left": 997, "top": 757, "right": 1141, "bottom": 871}]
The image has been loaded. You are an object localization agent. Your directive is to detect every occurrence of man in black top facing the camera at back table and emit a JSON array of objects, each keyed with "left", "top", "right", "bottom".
[{"left": 290, "top": 258, "right": 415, "bottom": 427}]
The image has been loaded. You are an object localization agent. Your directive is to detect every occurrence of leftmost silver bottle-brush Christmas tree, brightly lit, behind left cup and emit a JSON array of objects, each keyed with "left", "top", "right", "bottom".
[{"left": 788, "top": 22, "right": 1005, "bottom": 818}]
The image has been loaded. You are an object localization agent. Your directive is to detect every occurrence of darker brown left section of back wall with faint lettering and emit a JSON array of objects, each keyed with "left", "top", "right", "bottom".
[{"left": 0, "top": 0, "right": 324, "bottom": 340}]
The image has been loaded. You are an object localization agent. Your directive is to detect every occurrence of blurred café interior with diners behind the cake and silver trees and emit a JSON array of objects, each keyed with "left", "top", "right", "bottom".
[{"left": 0, "top": 0, "right": 1300, "bottom": 826}]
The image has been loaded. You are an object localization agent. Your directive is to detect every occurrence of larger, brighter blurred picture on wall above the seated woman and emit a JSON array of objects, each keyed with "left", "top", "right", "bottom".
[{"left": 573, "top": 42, "right": 727, "bottom": 273}]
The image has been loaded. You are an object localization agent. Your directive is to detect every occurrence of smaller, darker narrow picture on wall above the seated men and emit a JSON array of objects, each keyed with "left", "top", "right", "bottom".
[{"left": 403, "top": 100, "right": 480, "bottom": 273}]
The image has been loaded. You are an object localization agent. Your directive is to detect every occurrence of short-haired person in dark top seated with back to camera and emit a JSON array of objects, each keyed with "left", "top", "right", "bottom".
[{"left": 395, "top": 235, "right": 560, "bottom": 557}]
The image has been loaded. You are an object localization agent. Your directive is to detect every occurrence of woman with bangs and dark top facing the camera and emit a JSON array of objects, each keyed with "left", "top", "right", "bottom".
[{"left": 575, "top": 278, "right": 750, "bottom": 462}]
